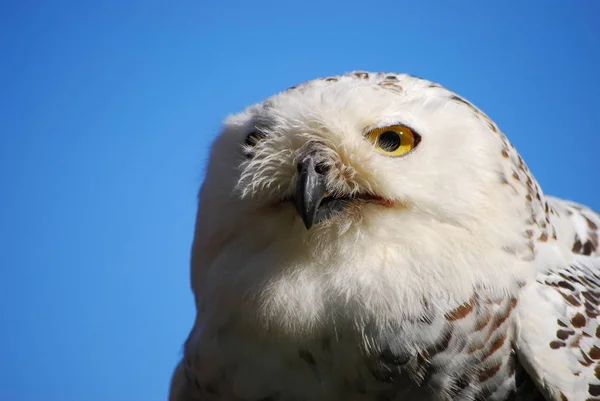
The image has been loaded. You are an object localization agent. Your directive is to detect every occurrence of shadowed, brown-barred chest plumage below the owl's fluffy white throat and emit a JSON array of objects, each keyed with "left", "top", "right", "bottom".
[{"left": 188, "top": 296, "right": 537, "bottom": 401}]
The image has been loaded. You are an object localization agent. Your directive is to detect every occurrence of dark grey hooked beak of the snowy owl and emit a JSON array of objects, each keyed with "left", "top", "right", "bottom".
[{"left": 294, "top": 155, "right": 327, "bottom": 229}]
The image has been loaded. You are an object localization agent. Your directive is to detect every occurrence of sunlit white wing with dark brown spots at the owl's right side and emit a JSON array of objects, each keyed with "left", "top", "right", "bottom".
[{"left": 514, "top": 198, "right": 600, "bottom": 401}]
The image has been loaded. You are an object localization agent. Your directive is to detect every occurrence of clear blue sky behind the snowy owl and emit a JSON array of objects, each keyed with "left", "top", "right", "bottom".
[{"left": 0, "top": 0, "right": 600, "bottom": 401}]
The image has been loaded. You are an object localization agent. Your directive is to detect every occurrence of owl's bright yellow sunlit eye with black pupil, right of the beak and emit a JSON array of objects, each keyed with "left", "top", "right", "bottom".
[{"left": 367, "top": 125, "right": 421, "bottom": 156}]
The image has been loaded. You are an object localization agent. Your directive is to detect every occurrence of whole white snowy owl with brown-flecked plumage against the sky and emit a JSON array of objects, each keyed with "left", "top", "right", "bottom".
[{"left": 170, "top": 72, "right": 600, "bottom": 401}]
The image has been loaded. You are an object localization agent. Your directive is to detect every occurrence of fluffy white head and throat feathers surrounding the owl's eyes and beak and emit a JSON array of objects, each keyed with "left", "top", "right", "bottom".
[{"left": 193, "top": 75, "right": 528, "bottom": 335}]
